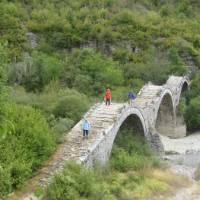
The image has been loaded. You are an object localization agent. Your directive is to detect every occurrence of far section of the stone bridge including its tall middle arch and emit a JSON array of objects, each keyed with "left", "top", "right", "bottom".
[{"left": 155, "top": 76, "right": 189, "bottom": 138}]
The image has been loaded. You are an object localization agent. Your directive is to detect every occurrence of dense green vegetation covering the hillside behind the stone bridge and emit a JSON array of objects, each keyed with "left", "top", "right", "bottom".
[{"left": 0, "top": 0, "right": 200, "bottom": 198}]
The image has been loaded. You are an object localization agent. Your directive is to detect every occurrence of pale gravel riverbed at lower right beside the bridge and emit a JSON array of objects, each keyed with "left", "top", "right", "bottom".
[{"left": 161, "top": 132, "right": 200, "bottom": 200}]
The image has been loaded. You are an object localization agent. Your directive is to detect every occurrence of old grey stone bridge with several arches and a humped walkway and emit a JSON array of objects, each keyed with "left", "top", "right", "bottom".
[{"left": 35, "top": 76, "right": 189, "bottom": 185}]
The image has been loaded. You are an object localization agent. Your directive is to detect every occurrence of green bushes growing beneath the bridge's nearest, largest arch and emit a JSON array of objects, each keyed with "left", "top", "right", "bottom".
[{"left": 110, "top": 127, "right": 155, "bottom": 172}]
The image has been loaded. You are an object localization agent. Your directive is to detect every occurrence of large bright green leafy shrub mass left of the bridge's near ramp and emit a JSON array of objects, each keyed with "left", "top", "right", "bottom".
[{"left": 0, "top": 104, "right": 55, "bottom": 196}]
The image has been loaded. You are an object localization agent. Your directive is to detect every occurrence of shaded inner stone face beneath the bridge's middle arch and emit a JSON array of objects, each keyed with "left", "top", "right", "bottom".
[{"left": 155, "top": 93, "right": 176, "bottom": 138}]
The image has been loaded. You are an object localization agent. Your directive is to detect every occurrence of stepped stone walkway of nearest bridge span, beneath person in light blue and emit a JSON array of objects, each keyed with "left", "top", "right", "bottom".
[{"left": 40, "top": 103, "right": 124, "bottom": 185}]
